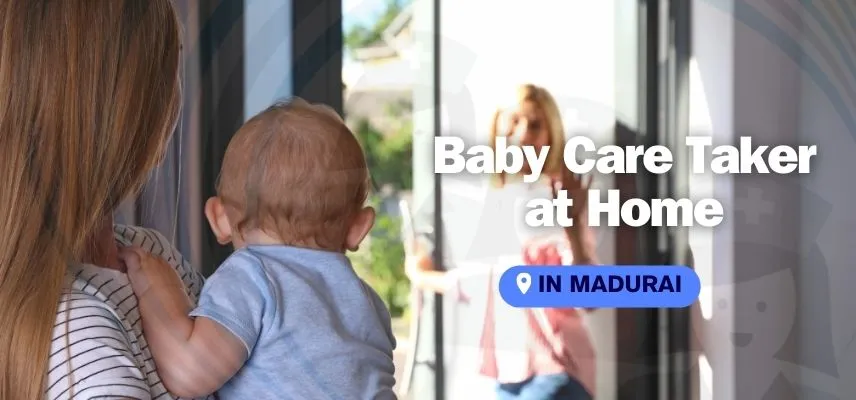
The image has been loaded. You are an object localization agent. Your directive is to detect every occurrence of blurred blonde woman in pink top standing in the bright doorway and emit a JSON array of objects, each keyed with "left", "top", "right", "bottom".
[{"left": 406, "top": 84, "right": 596, "bottom": 400}]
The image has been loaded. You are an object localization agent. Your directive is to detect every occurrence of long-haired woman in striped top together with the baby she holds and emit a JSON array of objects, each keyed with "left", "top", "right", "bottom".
[{"left": 0, "top": 0, "right": 395, "bottom": 400}]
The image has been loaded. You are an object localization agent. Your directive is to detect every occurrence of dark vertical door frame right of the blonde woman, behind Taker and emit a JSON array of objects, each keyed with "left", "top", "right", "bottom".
[{"left": 616, "top": 0, "right": 695, "bottom": 400}]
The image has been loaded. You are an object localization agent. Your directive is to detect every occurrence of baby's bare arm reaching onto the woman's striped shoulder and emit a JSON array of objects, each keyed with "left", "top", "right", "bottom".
[{"left": 123, "top": 248, "right": 248, "bottom": 398}]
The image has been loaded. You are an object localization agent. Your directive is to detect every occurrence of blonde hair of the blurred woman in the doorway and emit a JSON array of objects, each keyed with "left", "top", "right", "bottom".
[{"left": 490, "top": 83, "right": 565, "bottom": 186}]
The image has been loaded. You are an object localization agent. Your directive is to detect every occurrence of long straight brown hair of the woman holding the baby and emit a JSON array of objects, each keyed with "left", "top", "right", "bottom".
[{"left": 0, "top": 0, "right": 181, "bottom": 400}]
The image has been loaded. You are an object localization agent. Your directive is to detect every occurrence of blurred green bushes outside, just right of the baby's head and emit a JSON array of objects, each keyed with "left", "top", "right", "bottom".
[{"left": 351, "top": 105, "right": 413, "bottom": 317}]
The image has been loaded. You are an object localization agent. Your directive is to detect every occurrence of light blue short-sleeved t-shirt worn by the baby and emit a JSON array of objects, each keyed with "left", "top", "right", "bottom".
[{"left": 191, "top": 245, "right": 396, "bottom": 400}]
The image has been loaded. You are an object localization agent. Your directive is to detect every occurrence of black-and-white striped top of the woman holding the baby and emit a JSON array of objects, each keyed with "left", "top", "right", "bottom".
[{"left": 45, "top": 225, "right": 213, "bottom": 400}]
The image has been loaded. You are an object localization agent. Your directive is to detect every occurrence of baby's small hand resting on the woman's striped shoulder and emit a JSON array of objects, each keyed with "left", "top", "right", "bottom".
[{"left": 119, "top": 247, "right": 184, "bottom": 298}]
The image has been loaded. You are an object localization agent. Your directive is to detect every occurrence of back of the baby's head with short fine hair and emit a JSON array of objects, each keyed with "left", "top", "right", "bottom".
[{"left": 205, "top": 99, "right": 375, "bottom": 251}]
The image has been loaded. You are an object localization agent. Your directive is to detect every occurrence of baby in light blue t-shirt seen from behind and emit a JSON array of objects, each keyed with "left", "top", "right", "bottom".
[{"left": 122, "top": 99, "right": 395, "bottom": 400}]
